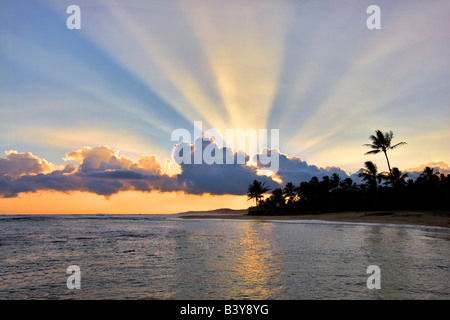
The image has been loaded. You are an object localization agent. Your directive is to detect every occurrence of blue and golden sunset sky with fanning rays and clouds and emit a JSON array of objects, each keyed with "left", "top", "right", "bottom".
[{"left": 0, "top": 0, "right": 450, "bottom": 214}]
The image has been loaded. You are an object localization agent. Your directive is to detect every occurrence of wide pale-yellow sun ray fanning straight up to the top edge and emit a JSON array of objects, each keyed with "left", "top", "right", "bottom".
[{"left": 176, "top": 1, "right": 291, "bottom": 129}]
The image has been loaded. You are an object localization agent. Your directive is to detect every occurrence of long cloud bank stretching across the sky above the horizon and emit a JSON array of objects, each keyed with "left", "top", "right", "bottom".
[{"left": 0, "top": 139, "right": 450, "bottom": 198}]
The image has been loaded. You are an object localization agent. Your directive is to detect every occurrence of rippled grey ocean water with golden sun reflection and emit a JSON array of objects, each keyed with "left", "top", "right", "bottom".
[{"left": 0, "top": 215, "right": 450, "bottom": 300}]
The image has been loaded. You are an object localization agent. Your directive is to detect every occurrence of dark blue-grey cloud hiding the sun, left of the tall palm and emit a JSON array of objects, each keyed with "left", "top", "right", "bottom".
[{"left": 172, "top": 139, "right": 348, "bottom": 195}]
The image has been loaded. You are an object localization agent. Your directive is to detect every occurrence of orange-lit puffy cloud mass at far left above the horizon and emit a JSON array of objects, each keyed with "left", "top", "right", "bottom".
[{"left": 0, "top": 146, "right": 176, "bottom": 198}]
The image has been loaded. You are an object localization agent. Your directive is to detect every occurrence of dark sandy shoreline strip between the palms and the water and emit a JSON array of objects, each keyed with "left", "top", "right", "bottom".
[{"left": 180, "top": 211, "right": 450, "bottom": 229}]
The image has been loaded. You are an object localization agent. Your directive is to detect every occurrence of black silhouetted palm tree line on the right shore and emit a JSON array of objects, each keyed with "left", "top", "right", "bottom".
[{"left": 247, "top": 130, "right": 450, "bottom": 215}]
